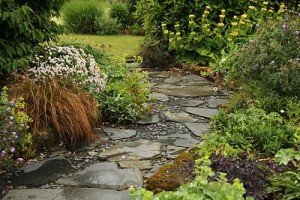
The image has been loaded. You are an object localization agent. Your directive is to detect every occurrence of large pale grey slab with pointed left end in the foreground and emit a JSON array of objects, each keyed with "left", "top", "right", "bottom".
[{"left": 56, "top": 163, "right": 143, "bottom": 190}]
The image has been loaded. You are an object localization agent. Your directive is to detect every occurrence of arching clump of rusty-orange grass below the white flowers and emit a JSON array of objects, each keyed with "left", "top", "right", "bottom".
[{"left": 12, "top": 78, "right": 99, "bottom": 147}]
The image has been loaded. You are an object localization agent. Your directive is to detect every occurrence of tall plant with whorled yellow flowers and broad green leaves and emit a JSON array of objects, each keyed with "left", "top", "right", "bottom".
[{"left": 162, "top": 3, "right": 285, "bottom": 65}]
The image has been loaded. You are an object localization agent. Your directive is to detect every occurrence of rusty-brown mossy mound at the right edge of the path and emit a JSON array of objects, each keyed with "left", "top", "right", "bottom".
[{"left": 145, "top": 151, "right": 195, "bottom": 193}]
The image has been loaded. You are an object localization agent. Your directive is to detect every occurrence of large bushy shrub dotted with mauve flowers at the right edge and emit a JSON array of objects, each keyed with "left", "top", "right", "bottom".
[{"left": 219, "top": 14, "right": 300, "bottom": 96}]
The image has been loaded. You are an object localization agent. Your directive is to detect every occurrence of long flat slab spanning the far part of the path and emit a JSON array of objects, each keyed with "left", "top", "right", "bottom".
[{"left": 154, "top": 85, "right": 224, "bottom": 97}]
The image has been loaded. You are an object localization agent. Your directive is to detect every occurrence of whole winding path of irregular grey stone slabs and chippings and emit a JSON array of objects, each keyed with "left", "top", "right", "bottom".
[{"left": 0, "top": 71, "right": 227, "bottom": 200}]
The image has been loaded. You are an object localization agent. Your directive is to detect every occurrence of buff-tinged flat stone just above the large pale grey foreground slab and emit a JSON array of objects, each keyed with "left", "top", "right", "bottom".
[{"left": 99, "top": 140, "right": 162, "bottom": 162}]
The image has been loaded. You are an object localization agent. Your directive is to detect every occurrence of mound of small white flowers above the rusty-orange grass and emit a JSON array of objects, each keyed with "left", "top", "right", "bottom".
[{"left": 28, "top": 46, "right": 107, "bottom": 93}]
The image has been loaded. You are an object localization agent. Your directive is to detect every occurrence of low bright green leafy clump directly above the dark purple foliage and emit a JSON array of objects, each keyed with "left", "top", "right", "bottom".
[{"left": 212, "top": 107, "right": 296, "bottom": 155}]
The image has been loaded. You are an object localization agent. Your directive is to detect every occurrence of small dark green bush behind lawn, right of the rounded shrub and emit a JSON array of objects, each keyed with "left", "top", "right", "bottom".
[{"left": 110, "top": 3, "right": 132, "bottom": 28}]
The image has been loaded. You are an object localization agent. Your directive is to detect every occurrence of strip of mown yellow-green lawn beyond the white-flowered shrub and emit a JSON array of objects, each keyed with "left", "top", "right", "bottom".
[{"left": 59, "top": 34, "right": 144, "bottom": 56}]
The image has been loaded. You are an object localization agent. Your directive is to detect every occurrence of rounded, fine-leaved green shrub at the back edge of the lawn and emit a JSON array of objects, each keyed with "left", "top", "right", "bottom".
[{"left": 61, "top": 0, "right": 104, "bottom": 34}]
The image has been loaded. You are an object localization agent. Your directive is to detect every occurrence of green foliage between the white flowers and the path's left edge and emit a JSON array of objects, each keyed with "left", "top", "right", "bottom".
[{"left": 84, "top": 47, "right": 150, "bottom": 123}]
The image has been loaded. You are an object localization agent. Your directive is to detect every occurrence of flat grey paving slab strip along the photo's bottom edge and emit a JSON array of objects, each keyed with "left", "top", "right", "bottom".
[{"left": 3, "top": 188, "right": 132, "bottom": 200}]
